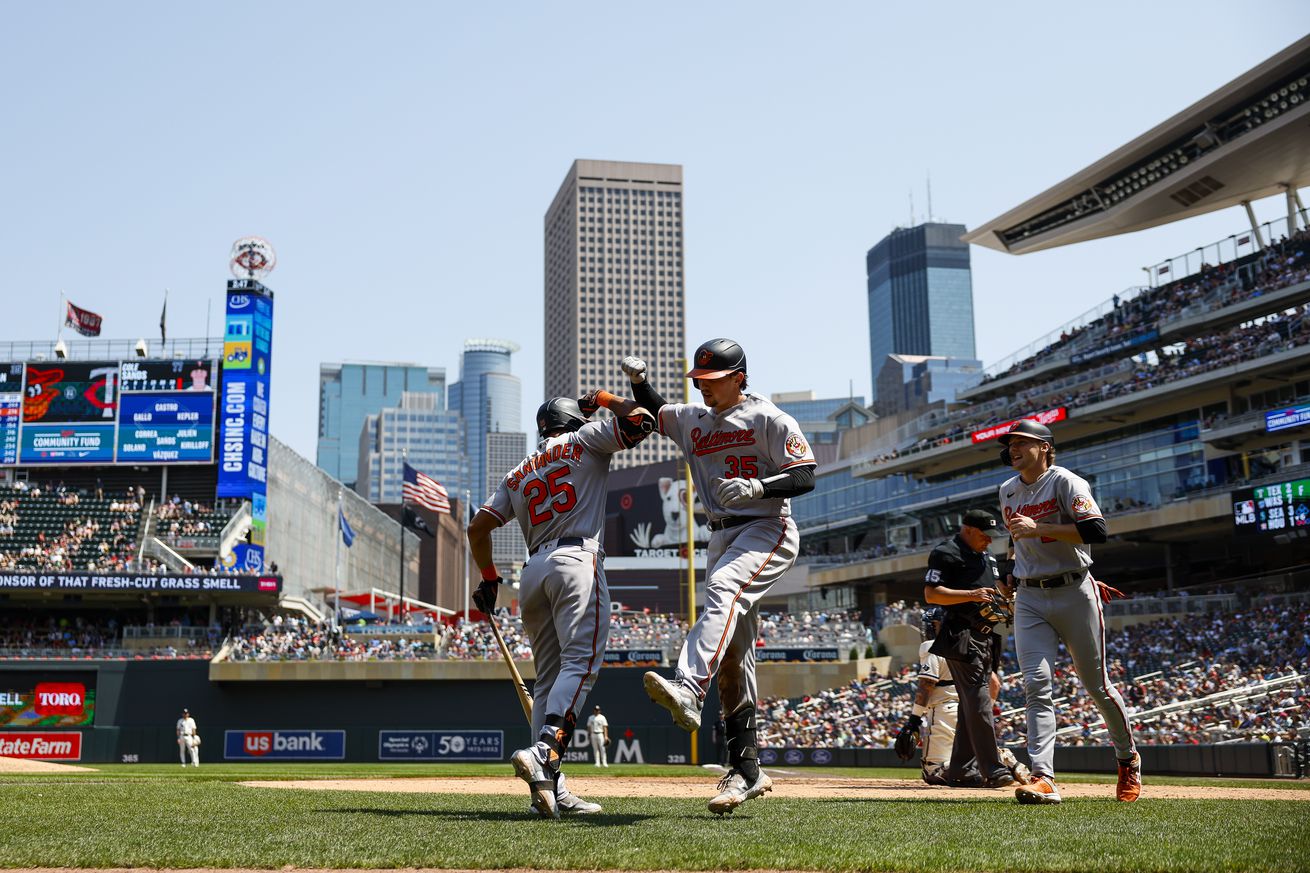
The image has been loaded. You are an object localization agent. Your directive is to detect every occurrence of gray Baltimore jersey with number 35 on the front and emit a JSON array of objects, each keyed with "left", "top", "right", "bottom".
[{"left": 658, "top": 393, "right": 815, "bottom": 519}]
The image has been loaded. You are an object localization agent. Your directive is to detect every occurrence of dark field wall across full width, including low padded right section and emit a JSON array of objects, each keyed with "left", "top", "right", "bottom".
[{"left": 0, "top": 661, "right": 1310, "bottom": 776}]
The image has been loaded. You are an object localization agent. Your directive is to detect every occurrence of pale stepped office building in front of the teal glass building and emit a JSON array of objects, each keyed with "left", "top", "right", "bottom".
[{"left": 355, "top": 391, "right": 468, "bottom": 503}]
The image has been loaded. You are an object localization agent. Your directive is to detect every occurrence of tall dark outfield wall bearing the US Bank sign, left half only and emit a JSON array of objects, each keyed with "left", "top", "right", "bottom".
[{"left": 0, "top": 661, "right": 718, "bottom": 763}]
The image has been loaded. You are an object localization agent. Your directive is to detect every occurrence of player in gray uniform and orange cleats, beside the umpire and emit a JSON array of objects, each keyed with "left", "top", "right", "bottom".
[{"left": 1000, "top": 419, "right": 1141, "bottom": 804}]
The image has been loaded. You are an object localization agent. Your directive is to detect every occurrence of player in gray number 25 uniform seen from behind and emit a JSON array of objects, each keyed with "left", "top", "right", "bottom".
[{"left": 469, "top": 392, "right": 655, "bottom": 818}]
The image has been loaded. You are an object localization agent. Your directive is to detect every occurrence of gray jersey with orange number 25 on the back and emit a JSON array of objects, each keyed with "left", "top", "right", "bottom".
[{"left": 482, "top": 418, "right": 627, "bottom": 552}]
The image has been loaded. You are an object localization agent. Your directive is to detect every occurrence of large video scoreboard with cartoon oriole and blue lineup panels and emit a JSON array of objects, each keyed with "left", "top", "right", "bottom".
[{"left": 0, "top": 358, "right": 216, "bottom": 467}]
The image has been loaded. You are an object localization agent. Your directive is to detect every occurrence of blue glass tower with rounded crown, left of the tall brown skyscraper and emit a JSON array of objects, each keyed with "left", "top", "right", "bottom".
[{"left": 451, "top": 340, "right": 516, "bottom": 506}]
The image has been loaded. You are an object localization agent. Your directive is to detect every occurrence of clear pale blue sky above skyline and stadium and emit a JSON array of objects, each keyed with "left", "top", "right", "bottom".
[{"left": 0, "top": 0, "right": 1310, "bottom": 459}]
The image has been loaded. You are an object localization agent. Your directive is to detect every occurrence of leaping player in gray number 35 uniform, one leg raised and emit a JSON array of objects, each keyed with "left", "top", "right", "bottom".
[{"left": 622, "top": 338, "right": 815, "bottom": 815}]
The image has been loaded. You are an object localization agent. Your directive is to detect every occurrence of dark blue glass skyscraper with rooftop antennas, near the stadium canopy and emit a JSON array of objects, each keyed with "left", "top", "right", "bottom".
[{"left": 865, "top": 223, "right": 973, "bottom": 400}]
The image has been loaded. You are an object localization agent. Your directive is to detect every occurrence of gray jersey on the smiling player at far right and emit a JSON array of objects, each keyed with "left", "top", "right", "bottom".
[{"left": 1001, "top": 467, "right": 1102, "bottom": 579}]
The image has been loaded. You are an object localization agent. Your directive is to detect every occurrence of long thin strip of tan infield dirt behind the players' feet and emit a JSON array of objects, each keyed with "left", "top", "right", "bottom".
[{"left": 238, "top": 772, "right": 1310, "bottom": 802}]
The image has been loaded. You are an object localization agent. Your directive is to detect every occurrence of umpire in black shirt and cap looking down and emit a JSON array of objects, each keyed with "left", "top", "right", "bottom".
[{"left": 924, "top": 510, "right": 1017, "bottom": 788}]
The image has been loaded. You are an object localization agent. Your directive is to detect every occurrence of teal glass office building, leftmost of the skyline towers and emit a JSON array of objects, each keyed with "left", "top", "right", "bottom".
[{"left": 316, "top": 363, "right": 445, "bottom": 488}]
